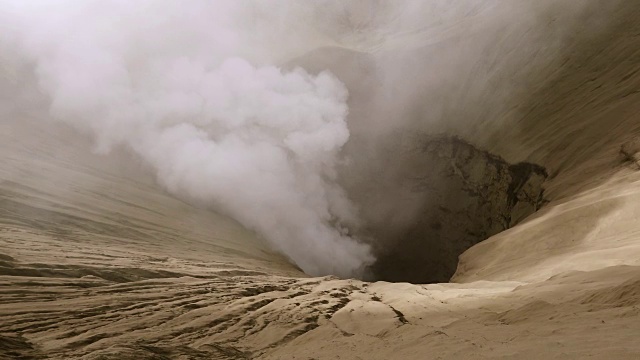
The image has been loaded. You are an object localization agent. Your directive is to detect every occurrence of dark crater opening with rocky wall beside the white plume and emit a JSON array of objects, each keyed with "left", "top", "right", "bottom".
[{"left": 342, "top": 135, "right": 548, "bottom": 283}]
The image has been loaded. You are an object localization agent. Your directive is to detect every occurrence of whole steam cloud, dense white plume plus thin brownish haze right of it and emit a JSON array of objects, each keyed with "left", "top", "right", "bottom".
[{"left": 0, "top": 0, "right": 616, "bottom": 276}]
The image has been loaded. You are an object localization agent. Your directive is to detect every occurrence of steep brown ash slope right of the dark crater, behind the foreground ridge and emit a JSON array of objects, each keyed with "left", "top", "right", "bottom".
[{"left": 456, "top": 3, "right": 640, "bottom": 281}]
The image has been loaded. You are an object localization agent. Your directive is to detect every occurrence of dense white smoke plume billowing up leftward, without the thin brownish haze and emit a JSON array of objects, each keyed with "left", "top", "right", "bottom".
[{"left": 0, "top": 0, "right": 373, "bottom": 276}]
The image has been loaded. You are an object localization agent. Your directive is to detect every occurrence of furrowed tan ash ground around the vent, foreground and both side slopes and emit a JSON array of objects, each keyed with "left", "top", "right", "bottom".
[{"left": 0, "top": 2, "right": 640, "bottom": 359}]
